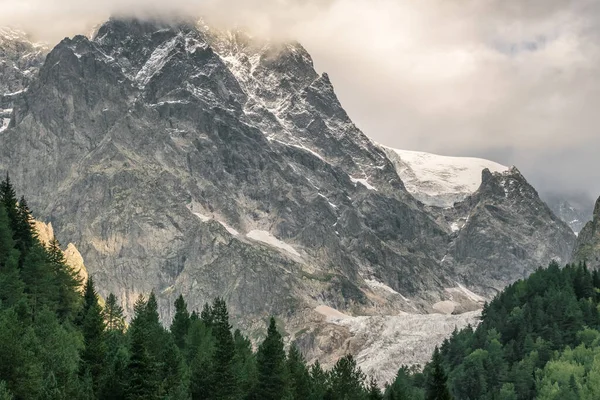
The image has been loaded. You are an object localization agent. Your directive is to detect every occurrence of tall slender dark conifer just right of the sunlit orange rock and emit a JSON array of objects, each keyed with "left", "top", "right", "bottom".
[{"left": 80, "top": 278, "right": 106, "bottom": 392}]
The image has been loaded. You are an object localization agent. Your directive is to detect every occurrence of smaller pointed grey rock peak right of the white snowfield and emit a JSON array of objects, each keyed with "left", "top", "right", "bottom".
[{"left": 443, "top": 167, "right": 575, "bottom": 296}]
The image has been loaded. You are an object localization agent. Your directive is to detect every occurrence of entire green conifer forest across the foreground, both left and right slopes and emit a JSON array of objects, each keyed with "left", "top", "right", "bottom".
[{"left": 0, "top": 177, "right": 600, "bottom": 400}]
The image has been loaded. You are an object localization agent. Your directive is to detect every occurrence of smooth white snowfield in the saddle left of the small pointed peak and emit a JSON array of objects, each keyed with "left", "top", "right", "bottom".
[{"left": 381, "top": 146, "right": 509, "bottom": 207}]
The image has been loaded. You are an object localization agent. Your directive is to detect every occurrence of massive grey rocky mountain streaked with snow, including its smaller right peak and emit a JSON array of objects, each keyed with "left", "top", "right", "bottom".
[{"left": 0, "top": 19, "right": 575, "bottom": 382}]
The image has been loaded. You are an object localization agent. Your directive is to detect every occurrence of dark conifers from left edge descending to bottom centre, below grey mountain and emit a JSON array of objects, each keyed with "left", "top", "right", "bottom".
[{"left": 0, "top": 176, "right": 394, "bottom": 400}]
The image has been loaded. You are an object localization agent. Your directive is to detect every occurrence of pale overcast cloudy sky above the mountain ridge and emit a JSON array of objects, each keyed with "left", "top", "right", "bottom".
[{"left": 0, "top": 0, "right": 600, "bottom": 198}]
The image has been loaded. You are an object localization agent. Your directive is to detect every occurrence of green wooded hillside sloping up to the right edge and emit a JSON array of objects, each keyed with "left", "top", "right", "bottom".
[{"left": 386, "top": 263, "right": 600, "bottom": 400}]
